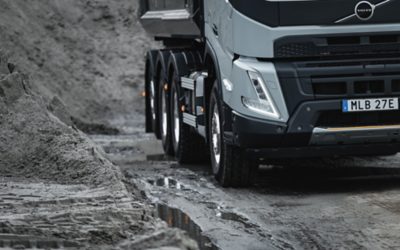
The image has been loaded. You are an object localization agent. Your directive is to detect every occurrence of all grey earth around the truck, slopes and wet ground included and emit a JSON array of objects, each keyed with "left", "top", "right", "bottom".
[{"left": 0, "top": 0, "right": 400, "bottom": 250}]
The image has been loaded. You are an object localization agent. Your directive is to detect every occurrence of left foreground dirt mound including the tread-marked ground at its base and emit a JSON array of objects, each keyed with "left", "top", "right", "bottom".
[{"left": 0, "top": 56, "right": 198, "bottom": 250}]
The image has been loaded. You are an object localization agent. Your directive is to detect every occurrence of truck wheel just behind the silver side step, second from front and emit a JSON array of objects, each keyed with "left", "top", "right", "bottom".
[{"left": 170, "top": 70, "right": 206, "bottom": 164}]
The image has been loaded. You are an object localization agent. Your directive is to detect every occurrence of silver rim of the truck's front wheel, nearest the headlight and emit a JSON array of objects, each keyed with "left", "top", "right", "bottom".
[{"left": 211, "top": 105, "right": 221, "bottom": 174}]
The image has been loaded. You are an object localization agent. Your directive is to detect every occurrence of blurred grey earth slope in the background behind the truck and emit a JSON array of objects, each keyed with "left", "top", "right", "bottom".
[{"left": 0, "top": 0, "right": 154, "bottom": 128}]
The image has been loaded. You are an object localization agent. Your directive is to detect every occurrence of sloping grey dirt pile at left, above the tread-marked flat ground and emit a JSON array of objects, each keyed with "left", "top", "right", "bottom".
[{"left": 0, "top": 54, "right": 122, "bottom": 186}]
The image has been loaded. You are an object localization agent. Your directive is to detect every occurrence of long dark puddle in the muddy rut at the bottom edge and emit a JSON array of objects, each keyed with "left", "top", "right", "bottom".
[{"left": 157, "top": 204, "right": 219, "bottom": 250}]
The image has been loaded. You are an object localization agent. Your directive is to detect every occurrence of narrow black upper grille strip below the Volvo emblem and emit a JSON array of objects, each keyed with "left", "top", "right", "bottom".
[{"left": 274, "top": 34, "right": 400, "bottom": 58}]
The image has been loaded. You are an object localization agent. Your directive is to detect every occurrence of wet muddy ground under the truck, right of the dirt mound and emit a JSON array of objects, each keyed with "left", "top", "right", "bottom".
[{"left": 92, "top": 123, "right": 400, "bottom": 250}]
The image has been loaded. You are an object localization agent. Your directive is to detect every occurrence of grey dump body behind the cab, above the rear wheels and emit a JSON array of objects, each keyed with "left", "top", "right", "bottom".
[{"left": 140, "top": 0, "right": 202, "bottom": 38}]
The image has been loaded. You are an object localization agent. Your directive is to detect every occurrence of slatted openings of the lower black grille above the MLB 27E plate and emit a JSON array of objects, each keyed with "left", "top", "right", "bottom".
[{"left": 298, "top": 59, "right": 400, "bottom": 99}]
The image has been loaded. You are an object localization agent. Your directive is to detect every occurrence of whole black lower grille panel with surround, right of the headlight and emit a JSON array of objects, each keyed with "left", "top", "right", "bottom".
[{"left": 275, "top": 55, "right": 400, "bottom": 114}]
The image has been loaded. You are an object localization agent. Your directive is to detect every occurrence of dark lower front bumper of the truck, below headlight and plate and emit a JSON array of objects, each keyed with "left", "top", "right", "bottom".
[{"left": 224, "top": 100, "right": 400, "bottom": 158}]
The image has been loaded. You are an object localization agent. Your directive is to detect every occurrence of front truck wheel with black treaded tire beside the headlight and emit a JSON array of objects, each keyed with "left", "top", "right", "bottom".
[{"left": 208, "top": 84, "right": 258, "bottom": 187}]
